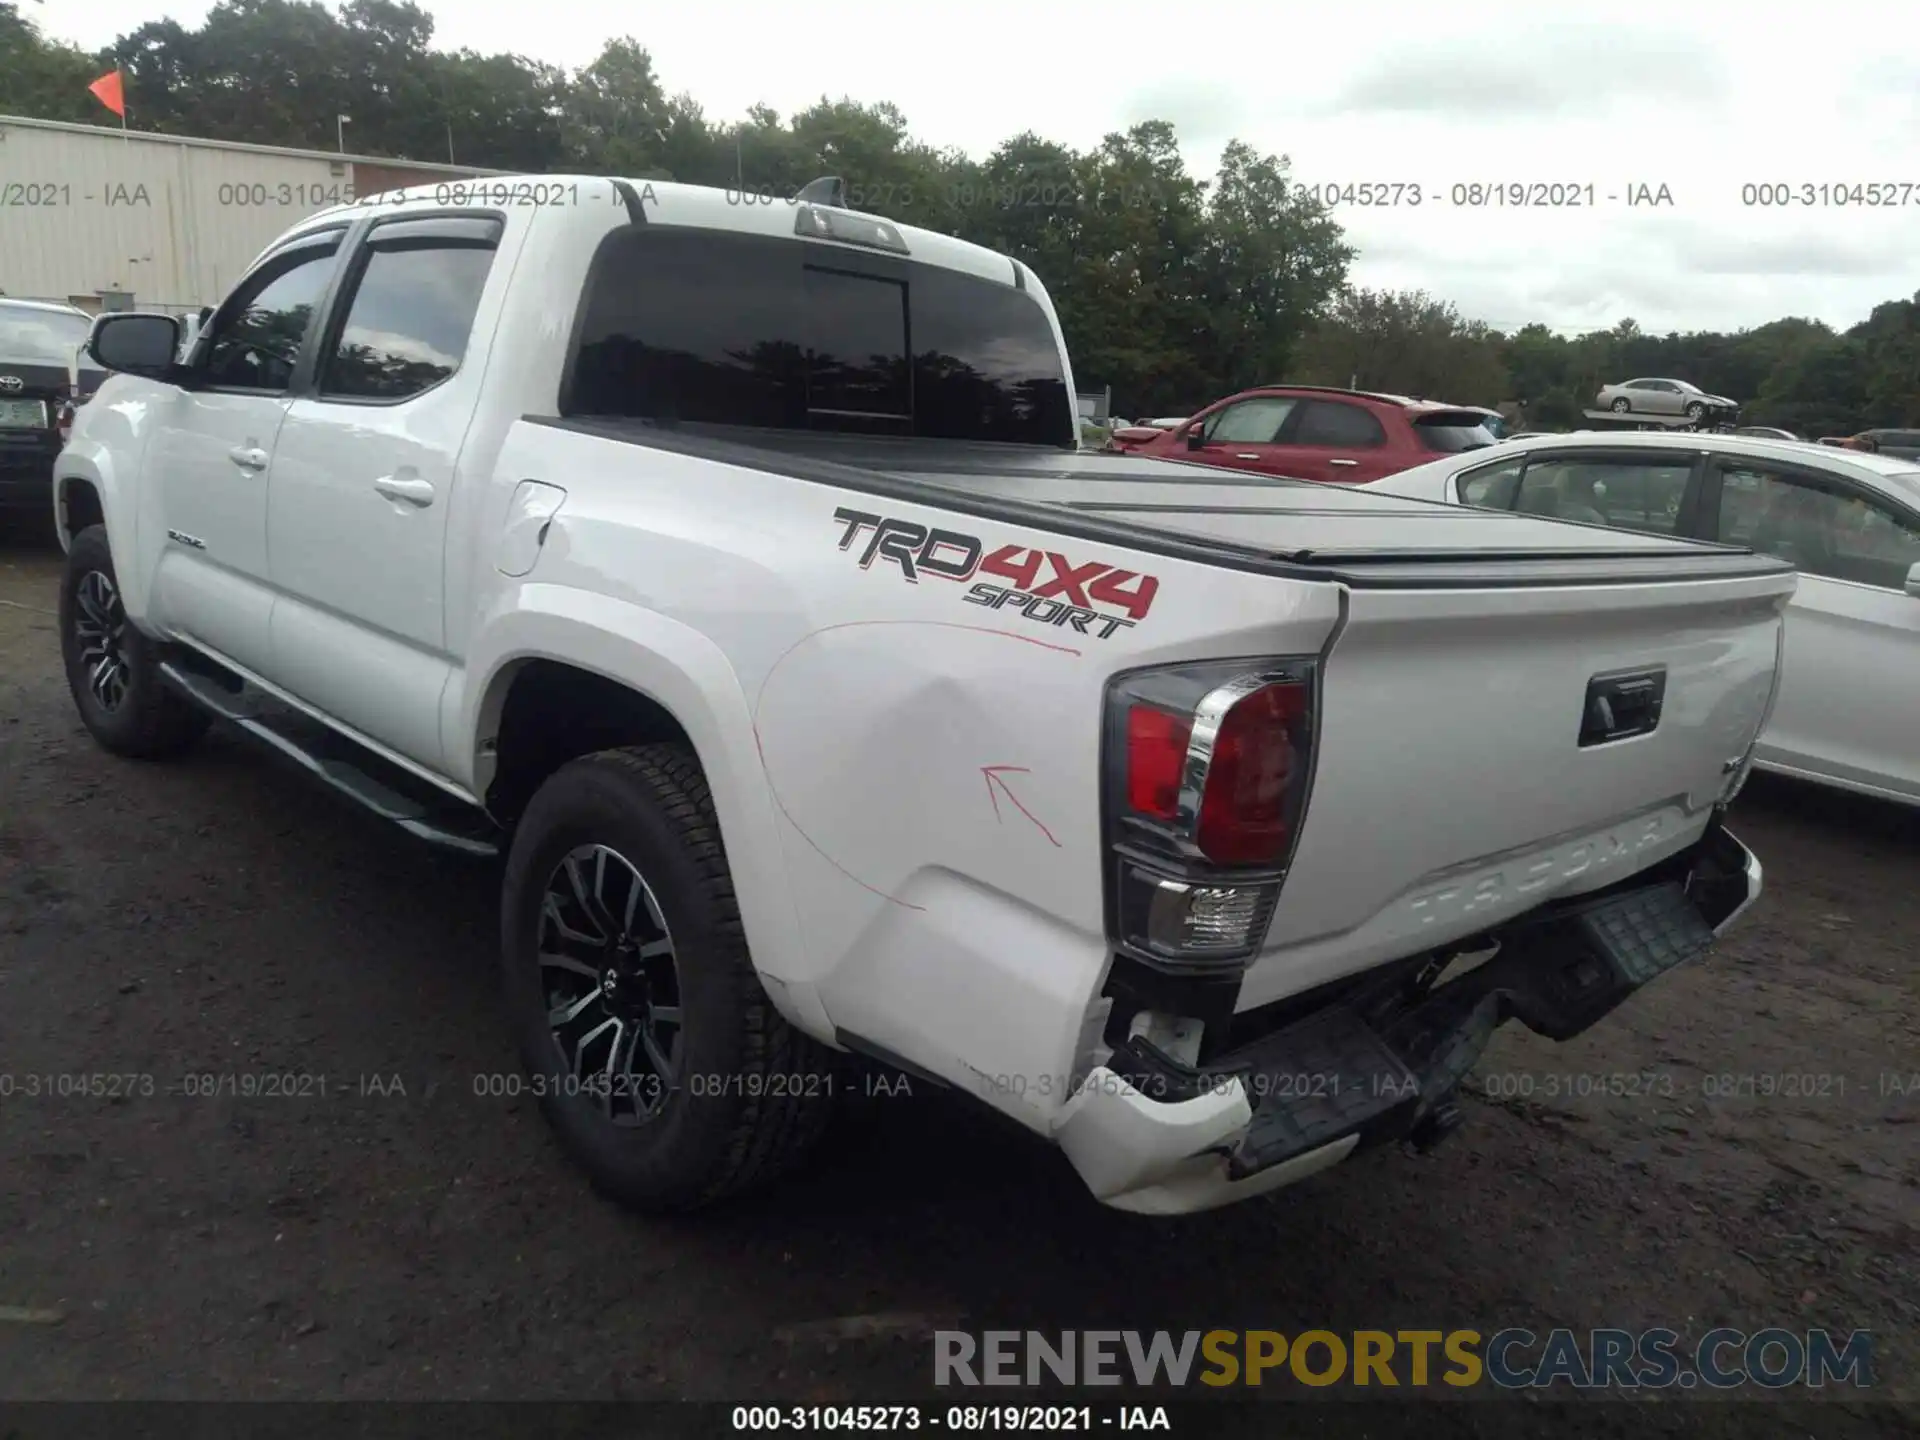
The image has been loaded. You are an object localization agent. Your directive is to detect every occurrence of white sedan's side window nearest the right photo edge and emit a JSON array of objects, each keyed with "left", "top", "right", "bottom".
[{"left": 1720, "top": 465, "right": 1920, "bottom": 589}]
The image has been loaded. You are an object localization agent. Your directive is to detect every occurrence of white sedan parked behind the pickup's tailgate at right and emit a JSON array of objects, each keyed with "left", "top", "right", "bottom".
[{"left": 1365, "top": 434, "right": 1920, "bottom": 804}]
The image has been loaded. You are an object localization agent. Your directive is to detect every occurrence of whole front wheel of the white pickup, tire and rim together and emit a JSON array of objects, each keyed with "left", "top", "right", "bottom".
[{"left": 60, "top": 524, "right": 213, "bottom": 760}]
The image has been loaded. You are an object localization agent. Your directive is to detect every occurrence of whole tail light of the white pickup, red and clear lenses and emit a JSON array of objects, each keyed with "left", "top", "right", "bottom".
[{"left": 1106, "top": 660, "right": 1317, "bottom": 972}]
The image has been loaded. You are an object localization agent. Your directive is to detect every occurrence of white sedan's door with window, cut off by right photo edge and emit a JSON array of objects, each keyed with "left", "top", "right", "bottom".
[{"left": 1707, "top": 455, "right": 1920, "bottom": 799}]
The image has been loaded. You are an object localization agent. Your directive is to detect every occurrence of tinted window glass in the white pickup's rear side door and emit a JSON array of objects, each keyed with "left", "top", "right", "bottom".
[{"left": 321, "top": 246, "right": 493, "bottom": 399}]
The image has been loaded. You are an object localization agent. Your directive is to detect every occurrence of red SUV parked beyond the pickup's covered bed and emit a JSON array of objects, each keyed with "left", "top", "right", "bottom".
[{"left": 1114, "top": 386, "right": 1496, "bottom": 486}]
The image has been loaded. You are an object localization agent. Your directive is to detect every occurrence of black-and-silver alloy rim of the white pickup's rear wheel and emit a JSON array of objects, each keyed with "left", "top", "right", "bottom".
[{"left": 540, "top": 845, "right": 685, "bottom": 1125}]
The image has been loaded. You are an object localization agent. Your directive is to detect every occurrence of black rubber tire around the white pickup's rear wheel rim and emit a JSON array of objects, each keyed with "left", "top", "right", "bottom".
[{"left": 501, "top": 745, "right": 831, "bottom": 1212}]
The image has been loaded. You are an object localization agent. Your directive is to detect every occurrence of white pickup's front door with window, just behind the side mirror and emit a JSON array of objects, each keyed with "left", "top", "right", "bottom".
[{"left": 140, "top": 230, "right": 344, "bottom": 672}]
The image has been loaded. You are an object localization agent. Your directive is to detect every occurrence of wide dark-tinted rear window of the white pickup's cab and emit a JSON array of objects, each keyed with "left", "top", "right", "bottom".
[{"left": 563, "top": 225, "right": 1079, "bottom": 447}]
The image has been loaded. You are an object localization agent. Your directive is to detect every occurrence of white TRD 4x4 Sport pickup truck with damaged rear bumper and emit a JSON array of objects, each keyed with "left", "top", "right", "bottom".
[{"left": 56, "top": 177, "right": 1793, "bottom": 1213}]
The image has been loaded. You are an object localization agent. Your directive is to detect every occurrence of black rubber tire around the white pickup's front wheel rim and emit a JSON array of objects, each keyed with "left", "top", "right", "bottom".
[{"left": 60, "top": 524, "right": 213, "bottom": 760}]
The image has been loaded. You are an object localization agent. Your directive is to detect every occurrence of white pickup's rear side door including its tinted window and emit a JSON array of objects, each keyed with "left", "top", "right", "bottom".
[{"left": 267, "top": 215, "right": 511, "bottom": 770}]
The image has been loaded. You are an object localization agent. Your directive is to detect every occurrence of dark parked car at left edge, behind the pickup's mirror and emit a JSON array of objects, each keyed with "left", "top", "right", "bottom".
[{"left": 0, "top": 298, "right": 106, "bottom": 524}]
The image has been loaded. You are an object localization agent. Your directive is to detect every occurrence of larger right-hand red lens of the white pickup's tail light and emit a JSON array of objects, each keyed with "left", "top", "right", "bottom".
[{"left": 1194, "top": 684, "right": 1308, "bottom": 866}]
